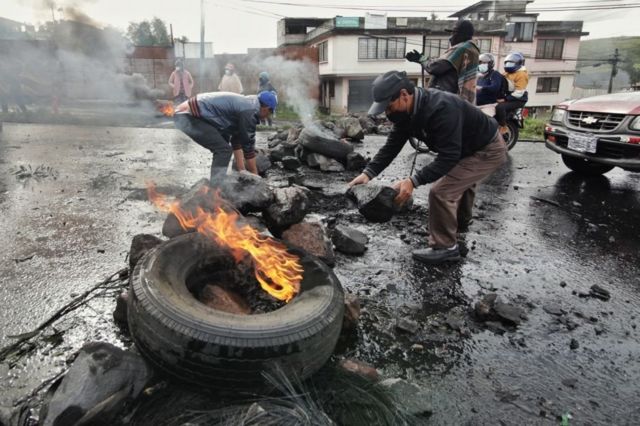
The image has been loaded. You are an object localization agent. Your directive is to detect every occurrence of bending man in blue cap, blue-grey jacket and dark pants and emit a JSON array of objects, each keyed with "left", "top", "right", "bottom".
[{"left": 174, "top": 92, "right": 278, "bottom": 186}]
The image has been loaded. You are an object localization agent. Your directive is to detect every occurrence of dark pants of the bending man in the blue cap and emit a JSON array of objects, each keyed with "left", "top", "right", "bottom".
[{"left": 174, "top": 114, "right": 232, "bottom": 186}]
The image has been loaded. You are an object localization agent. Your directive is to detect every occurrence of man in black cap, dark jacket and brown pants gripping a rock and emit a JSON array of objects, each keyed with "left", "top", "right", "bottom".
[{"left": 349, "top": 71, "right": 507, "bottom": 264}]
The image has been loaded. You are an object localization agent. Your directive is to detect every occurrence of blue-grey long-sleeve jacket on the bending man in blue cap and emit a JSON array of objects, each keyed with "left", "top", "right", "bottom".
[{"left": 189, "top": 92, "right": 260, "bottom": 158}]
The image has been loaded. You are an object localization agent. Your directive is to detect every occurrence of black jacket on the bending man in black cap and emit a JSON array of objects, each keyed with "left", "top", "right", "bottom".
[{"left": 364, "top": 88, "right": 498, "bottom": 186}]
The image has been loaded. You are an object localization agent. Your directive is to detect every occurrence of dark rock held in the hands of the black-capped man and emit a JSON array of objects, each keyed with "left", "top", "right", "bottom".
[{"left": 347, "top": 183, "right": 398, "bottom": 222}]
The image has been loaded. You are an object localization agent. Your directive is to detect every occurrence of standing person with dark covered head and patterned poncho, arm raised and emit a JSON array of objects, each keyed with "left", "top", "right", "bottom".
[{"left": 406, "top": 20, "right": 480, "bottom": 104}]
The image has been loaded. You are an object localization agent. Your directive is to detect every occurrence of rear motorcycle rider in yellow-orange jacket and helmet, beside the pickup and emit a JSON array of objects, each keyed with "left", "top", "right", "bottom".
[{"left": 496, "top": 52, "right": 529, "bottom": 133}]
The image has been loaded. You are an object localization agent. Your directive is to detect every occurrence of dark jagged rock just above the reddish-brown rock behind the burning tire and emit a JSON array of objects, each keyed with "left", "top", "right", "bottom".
[{"left": 262, "top": 186, "right": 310, "bottom": 234}]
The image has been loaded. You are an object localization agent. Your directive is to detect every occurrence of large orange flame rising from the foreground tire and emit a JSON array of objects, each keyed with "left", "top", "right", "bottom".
[{"left": 147, "top": 183, "right": 303, "bottom": 302}]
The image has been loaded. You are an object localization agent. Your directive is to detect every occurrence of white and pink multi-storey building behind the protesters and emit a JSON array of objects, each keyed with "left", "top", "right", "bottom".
[{"left": 278, "top": 0, "right": 587, "bottom": 114}]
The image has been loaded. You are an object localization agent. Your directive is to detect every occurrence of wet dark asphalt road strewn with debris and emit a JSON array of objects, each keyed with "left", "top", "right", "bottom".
[{"left": 0, "top": 124, "right": 640, "bottom": 424}]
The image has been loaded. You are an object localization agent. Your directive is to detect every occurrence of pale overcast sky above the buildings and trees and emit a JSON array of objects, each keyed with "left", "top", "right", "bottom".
[{"left": 5, "top": 0, "right": 640, "bottom": 53}]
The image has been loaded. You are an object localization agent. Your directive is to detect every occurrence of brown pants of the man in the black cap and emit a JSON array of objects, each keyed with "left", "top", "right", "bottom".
[{"left": 429, "top": 133, "right": 507, "bottom": 248}]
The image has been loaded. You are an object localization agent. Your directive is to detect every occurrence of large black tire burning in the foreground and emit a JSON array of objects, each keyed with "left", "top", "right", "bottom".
[{"left": 128, "top": 233, "right": 344, "bottom": 387}]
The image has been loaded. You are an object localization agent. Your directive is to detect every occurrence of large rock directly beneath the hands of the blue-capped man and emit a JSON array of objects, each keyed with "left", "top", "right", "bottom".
[{"left": 221, "top": 171, "right": 273, "bottom": 214}]
